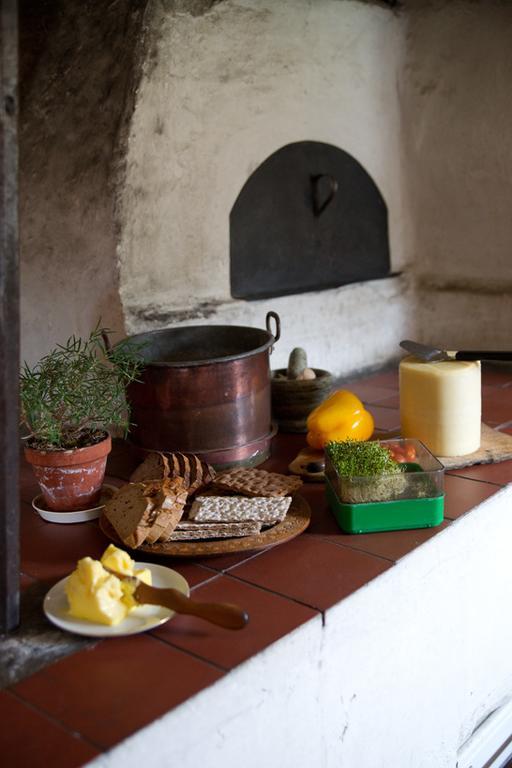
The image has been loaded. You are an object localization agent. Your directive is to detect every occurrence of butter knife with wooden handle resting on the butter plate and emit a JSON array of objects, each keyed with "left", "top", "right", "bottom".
[{"left": 103, "top": 566, "right": 249, "bottom": 629}]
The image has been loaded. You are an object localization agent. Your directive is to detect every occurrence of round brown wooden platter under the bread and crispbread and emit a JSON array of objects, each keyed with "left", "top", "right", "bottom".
[{"left": 99, "top": 494, "right": 311, "bottom": 557}]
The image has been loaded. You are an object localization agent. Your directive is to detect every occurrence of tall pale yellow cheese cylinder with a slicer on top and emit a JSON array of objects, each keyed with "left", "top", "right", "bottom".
[{"left": 399, "top": 357, "right": 482, "bottom": 456}]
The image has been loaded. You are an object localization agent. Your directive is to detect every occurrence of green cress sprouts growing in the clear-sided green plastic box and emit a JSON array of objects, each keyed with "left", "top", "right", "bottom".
[{"left": 325, "top": 440, "right": 403, "bottom": 477}]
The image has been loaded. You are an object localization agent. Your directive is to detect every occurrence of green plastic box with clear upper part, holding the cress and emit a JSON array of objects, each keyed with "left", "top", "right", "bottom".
[{"left": 325, "top": 439, "right": 444, "bottom": 533}]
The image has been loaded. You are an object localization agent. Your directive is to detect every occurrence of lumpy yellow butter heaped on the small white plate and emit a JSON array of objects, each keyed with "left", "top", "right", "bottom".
[{"left": 65, "top": 544, "right": 151, "bottom": 626}]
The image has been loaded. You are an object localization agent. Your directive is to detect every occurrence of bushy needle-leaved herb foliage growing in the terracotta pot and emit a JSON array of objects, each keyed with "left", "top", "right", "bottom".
[{"left": 20, "top": 327, "right": 143, "bottom": 450}]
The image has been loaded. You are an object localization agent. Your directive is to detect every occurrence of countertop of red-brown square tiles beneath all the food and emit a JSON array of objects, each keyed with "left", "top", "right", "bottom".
[{"left": 4, "top": 367, "right": 512, "bottom": 768}]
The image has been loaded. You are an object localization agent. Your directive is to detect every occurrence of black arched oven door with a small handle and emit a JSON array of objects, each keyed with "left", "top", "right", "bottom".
[{"left": 230, "top": 141, "right": 390, "bottom": 299}]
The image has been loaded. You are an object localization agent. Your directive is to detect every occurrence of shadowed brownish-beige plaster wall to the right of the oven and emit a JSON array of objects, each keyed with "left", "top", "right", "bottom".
[{"left": 399, "top": 0, "right": 512, "bottom": 349}]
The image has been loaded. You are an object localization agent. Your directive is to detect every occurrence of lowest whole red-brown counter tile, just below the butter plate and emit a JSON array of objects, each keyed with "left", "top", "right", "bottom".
[{"left": 13, "top": 635, "right": 222, "bottom": 752}]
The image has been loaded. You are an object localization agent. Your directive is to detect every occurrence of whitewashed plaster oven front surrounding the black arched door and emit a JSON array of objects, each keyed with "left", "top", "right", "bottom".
[{"left": 119, "top": 0, "right": 408, "bottom": 373}]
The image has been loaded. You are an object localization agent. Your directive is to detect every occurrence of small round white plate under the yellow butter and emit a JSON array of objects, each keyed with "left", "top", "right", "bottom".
[{"left": 43, "top": 563, "right": 190, "bottom": 637}]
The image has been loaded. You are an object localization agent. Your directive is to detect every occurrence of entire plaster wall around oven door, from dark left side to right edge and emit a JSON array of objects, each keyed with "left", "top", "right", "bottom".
[{"left": 20, "top": 0, "right": 512, "bottom": 374}]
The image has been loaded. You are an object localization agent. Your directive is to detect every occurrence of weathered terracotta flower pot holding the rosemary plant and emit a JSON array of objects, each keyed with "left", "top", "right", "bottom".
[{"left": 25, "top": 435, "right": 112, "bottom": 512}]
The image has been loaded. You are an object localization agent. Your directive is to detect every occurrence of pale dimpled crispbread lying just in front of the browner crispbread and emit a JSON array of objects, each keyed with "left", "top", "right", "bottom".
[{"left": 188, "top": 496, "right": 292, "bottom": 525}]
